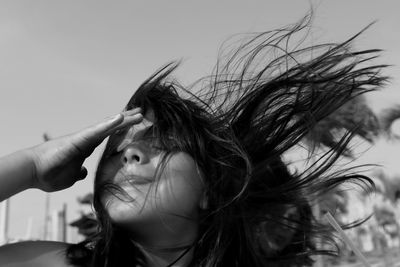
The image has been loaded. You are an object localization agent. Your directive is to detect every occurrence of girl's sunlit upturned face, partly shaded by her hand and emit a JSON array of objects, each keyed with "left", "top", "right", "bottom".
[{"left": 96, "top": 110, "right": 203, "bottom": 230}]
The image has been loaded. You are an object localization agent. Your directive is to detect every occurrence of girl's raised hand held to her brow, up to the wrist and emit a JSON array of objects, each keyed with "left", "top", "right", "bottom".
[{"left": 31, "top": 108, "right": 143, "bottom": 192}]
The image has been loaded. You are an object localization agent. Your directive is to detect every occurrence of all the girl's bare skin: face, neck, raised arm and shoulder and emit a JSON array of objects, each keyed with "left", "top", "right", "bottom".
[{"left": 0, "top": 109, "right": 204, "bottom": 267}]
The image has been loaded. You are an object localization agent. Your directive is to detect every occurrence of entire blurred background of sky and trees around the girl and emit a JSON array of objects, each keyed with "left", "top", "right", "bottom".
[{"left": 0, "top": 0, "right": 400, "bottom": 266}]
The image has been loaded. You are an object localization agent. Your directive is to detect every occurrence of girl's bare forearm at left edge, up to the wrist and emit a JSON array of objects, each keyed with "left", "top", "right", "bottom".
[{"left": 0, "top": 149, "right": 35, "bottom": 201}]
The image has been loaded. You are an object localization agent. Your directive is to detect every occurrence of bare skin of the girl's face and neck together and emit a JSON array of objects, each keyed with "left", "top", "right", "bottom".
[{"left": 96, "top": 110, "right": 203, "bottom": 266}]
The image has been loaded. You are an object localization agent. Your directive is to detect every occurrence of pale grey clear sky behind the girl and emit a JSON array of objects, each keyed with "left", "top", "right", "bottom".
[{"left": 0, "top": 0, "right": 400, "bottom": 241}]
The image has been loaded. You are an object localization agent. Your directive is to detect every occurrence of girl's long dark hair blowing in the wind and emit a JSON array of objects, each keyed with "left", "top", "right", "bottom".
[{"left": 68, "top": 19, "right": 386, "bottom": 267}]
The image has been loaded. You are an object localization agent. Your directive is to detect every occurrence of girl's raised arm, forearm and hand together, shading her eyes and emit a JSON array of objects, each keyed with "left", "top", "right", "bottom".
[{"left": 0, "top": 109, "right": 143, "bottom": 201}]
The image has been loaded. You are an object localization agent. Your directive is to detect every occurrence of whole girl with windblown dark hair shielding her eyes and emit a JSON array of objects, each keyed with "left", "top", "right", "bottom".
[{"left": 0, "top": 19, "right": 386, "bottom": 267}]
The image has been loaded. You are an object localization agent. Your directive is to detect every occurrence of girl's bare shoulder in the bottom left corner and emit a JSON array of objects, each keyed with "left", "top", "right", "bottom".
[{"left": 0, "top": 241, "right": 72, "bottom": 267}]
